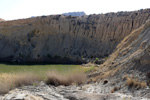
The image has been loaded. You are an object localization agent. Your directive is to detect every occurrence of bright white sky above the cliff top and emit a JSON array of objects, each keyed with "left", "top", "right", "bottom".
[{"left": 0, "top": 0, "right": 150, "bottom": 20}]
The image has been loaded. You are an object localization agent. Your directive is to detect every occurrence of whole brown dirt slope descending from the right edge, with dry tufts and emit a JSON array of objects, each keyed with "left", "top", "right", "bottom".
[{"left": 90, "top": 21, "right": 150, "bottom": 98}]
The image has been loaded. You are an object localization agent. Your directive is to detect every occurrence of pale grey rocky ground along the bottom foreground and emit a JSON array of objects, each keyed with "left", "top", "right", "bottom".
[{"left": 0, "top": 83, "right": 149, "bottom": 100}]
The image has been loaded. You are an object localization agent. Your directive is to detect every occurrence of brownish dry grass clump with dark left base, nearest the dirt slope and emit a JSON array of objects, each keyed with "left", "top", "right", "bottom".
[{"left": 46, "top": 71, "right": 86, "bottom": 86}]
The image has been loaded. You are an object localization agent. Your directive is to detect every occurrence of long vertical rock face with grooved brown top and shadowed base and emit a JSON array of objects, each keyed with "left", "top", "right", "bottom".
[{"left": 0, "top": 9, "right": 150, "bottom": 63}]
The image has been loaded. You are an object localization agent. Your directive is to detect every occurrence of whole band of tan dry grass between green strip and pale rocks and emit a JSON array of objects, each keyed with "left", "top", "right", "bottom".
[{"left": 0, "top": 71, "right": 86, "bottom": 94}]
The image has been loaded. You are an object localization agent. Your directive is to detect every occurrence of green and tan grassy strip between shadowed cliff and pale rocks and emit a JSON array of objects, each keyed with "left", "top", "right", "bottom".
[{"left": 0, "top": 64, "right": 88, "bottom": 94}]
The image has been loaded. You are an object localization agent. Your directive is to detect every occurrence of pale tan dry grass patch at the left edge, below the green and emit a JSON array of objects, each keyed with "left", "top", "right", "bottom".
[{"left": 0, "top": 73, "right": 41, "bottom": 94}]
